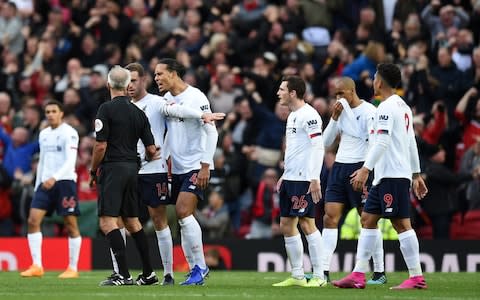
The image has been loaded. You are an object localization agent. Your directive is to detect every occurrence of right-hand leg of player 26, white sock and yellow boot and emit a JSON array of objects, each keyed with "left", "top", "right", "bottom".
[{"left": 299, "top": 217, "right": 327, "bottom": 287}]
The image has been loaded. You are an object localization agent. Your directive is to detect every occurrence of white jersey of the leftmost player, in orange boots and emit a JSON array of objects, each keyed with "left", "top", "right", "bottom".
[{"left": 35, "top": 123, "right": 79, "bottom": 189}]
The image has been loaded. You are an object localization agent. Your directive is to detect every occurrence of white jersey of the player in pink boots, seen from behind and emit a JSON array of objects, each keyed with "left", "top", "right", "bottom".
[{"left": 373, "top": 95, "right": 418, "bottom": 185}]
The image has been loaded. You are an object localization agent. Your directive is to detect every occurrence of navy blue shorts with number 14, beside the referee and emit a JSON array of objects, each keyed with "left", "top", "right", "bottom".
[{"left": 138, "top": 173, "right": 175, "bottom": 207}]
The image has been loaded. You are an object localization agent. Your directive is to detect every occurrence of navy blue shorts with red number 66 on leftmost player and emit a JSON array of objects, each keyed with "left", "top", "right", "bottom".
[{"left": 30, "top": 180, "right": 80, "bottom": 216}]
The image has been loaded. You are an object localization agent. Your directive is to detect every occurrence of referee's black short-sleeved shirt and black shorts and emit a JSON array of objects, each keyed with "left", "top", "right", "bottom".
[{"left": 95, "top": 96, "right": 155, "bottom": 217}]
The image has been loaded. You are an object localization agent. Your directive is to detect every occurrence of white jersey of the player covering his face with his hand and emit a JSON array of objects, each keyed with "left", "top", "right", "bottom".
[{"left": 335, "top": 101, "right": 376, "bottom": 163}]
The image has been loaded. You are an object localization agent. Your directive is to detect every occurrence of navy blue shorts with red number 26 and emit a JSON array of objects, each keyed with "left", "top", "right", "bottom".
[{"left": 279, "top": 180, "right": 315, "bottom": 218}]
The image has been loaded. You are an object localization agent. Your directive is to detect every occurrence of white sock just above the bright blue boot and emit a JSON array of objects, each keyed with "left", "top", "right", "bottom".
[{"left": 178, "top": 215, "right": 207, "bottom": 270}]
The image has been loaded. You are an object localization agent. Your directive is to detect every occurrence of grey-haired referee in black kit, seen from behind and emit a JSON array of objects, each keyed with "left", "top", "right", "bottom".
[{"left": 90, "top": 66, "right": 159, "bottom": 286}]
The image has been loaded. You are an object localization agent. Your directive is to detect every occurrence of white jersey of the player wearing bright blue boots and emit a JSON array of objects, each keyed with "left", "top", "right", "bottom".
[{"left": 164, "top": 86, "right": 213, "bottom": 174}]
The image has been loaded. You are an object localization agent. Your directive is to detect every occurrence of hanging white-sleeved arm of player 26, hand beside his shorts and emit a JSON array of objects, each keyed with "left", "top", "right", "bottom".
[{"left": 303, "top": 113, "right": 325, "bottom": 203}]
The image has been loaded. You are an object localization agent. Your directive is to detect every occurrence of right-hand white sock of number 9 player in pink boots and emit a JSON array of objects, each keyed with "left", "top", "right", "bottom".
[{"left": 398, "top": 229, "right": 422, "bottom": 277}]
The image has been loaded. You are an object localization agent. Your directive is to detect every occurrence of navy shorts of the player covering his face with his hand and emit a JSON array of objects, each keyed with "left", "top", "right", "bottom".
[{"left": 324, "top": 162, "right": 373, "bottom": 209}]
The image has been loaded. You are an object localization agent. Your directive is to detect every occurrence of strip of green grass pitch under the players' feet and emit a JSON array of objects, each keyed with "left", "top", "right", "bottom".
[{"left": 0, "top": 271, "right": 480, "bottom": 300}]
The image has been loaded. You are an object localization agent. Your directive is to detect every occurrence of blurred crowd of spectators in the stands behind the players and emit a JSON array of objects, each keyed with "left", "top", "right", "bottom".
[{"left": 0, "top": 0, "right": 480, "bottom": 239}]
